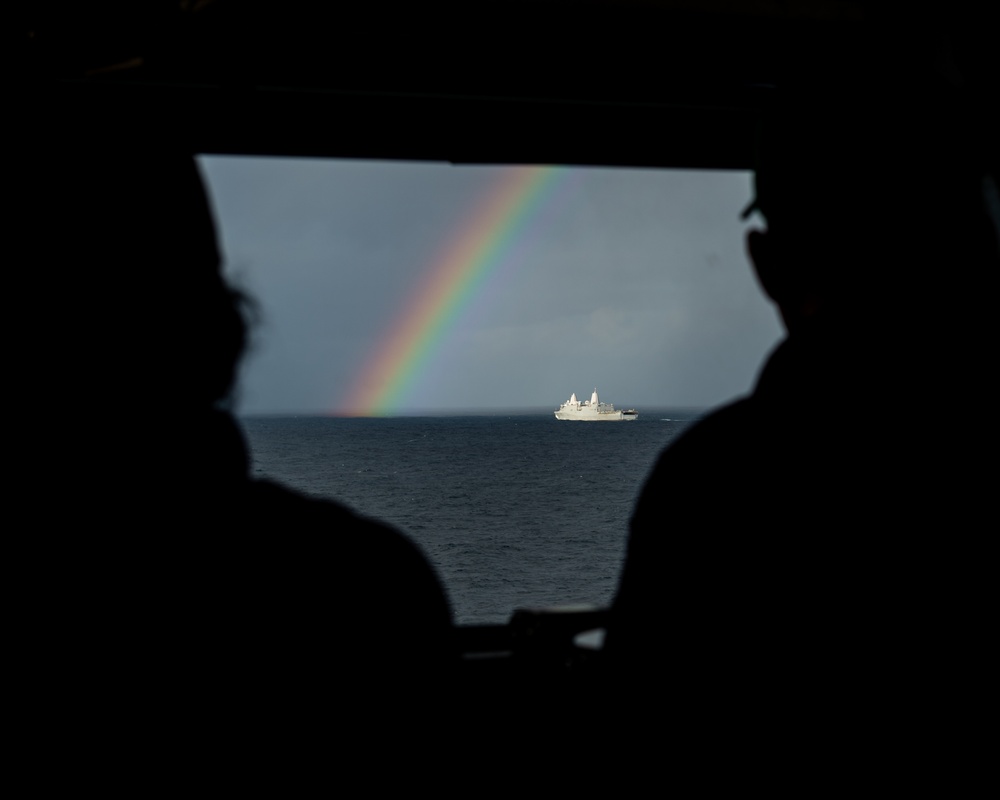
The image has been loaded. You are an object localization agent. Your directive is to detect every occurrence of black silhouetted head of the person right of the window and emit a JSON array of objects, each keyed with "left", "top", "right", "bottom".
[{"left": 744, "top": 40, "right": 1000, "bottom": 332}]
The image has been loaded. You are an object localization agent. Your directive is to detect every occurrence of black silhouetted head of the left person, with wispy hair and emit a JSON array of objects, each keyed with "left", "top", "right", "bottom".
[{"left": 19, "top": 132, "right": 246, "bottom": 413}]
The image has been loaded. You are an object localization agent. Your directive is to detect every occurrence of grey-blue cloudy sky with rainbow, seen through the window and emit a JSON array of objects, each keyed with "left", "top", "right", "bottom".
[{"left": 199, "top": 156, "right": 783, "bottom": 418}]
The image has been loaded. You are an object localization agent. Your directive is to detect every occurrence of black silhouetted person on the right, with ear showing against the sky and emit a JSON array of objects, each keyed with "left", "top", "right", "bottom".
[{"left": 603, "top": 42, "right": 1000, "bottom": 766}]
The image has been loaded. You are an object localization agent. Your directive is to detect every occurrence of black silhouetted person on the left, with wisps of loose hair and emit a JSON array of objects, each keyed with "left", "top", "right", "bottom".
[{"left": 9, "top": 122, "right": 459, "bottom": 778}]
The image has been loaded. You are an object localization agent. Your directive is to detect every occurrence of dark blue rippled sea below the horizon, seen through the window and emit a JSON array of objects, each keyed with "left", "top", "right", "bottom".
[{"left": 241, "top": 409, "right": 697, "bottom": 624}]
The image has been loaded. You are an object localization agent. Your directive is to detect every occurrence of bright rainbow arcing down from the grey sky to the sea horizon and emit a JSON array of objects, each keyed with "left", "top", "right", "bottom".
[{"left": 336, "top": 166, "right": 564, "bottom": 417}]
